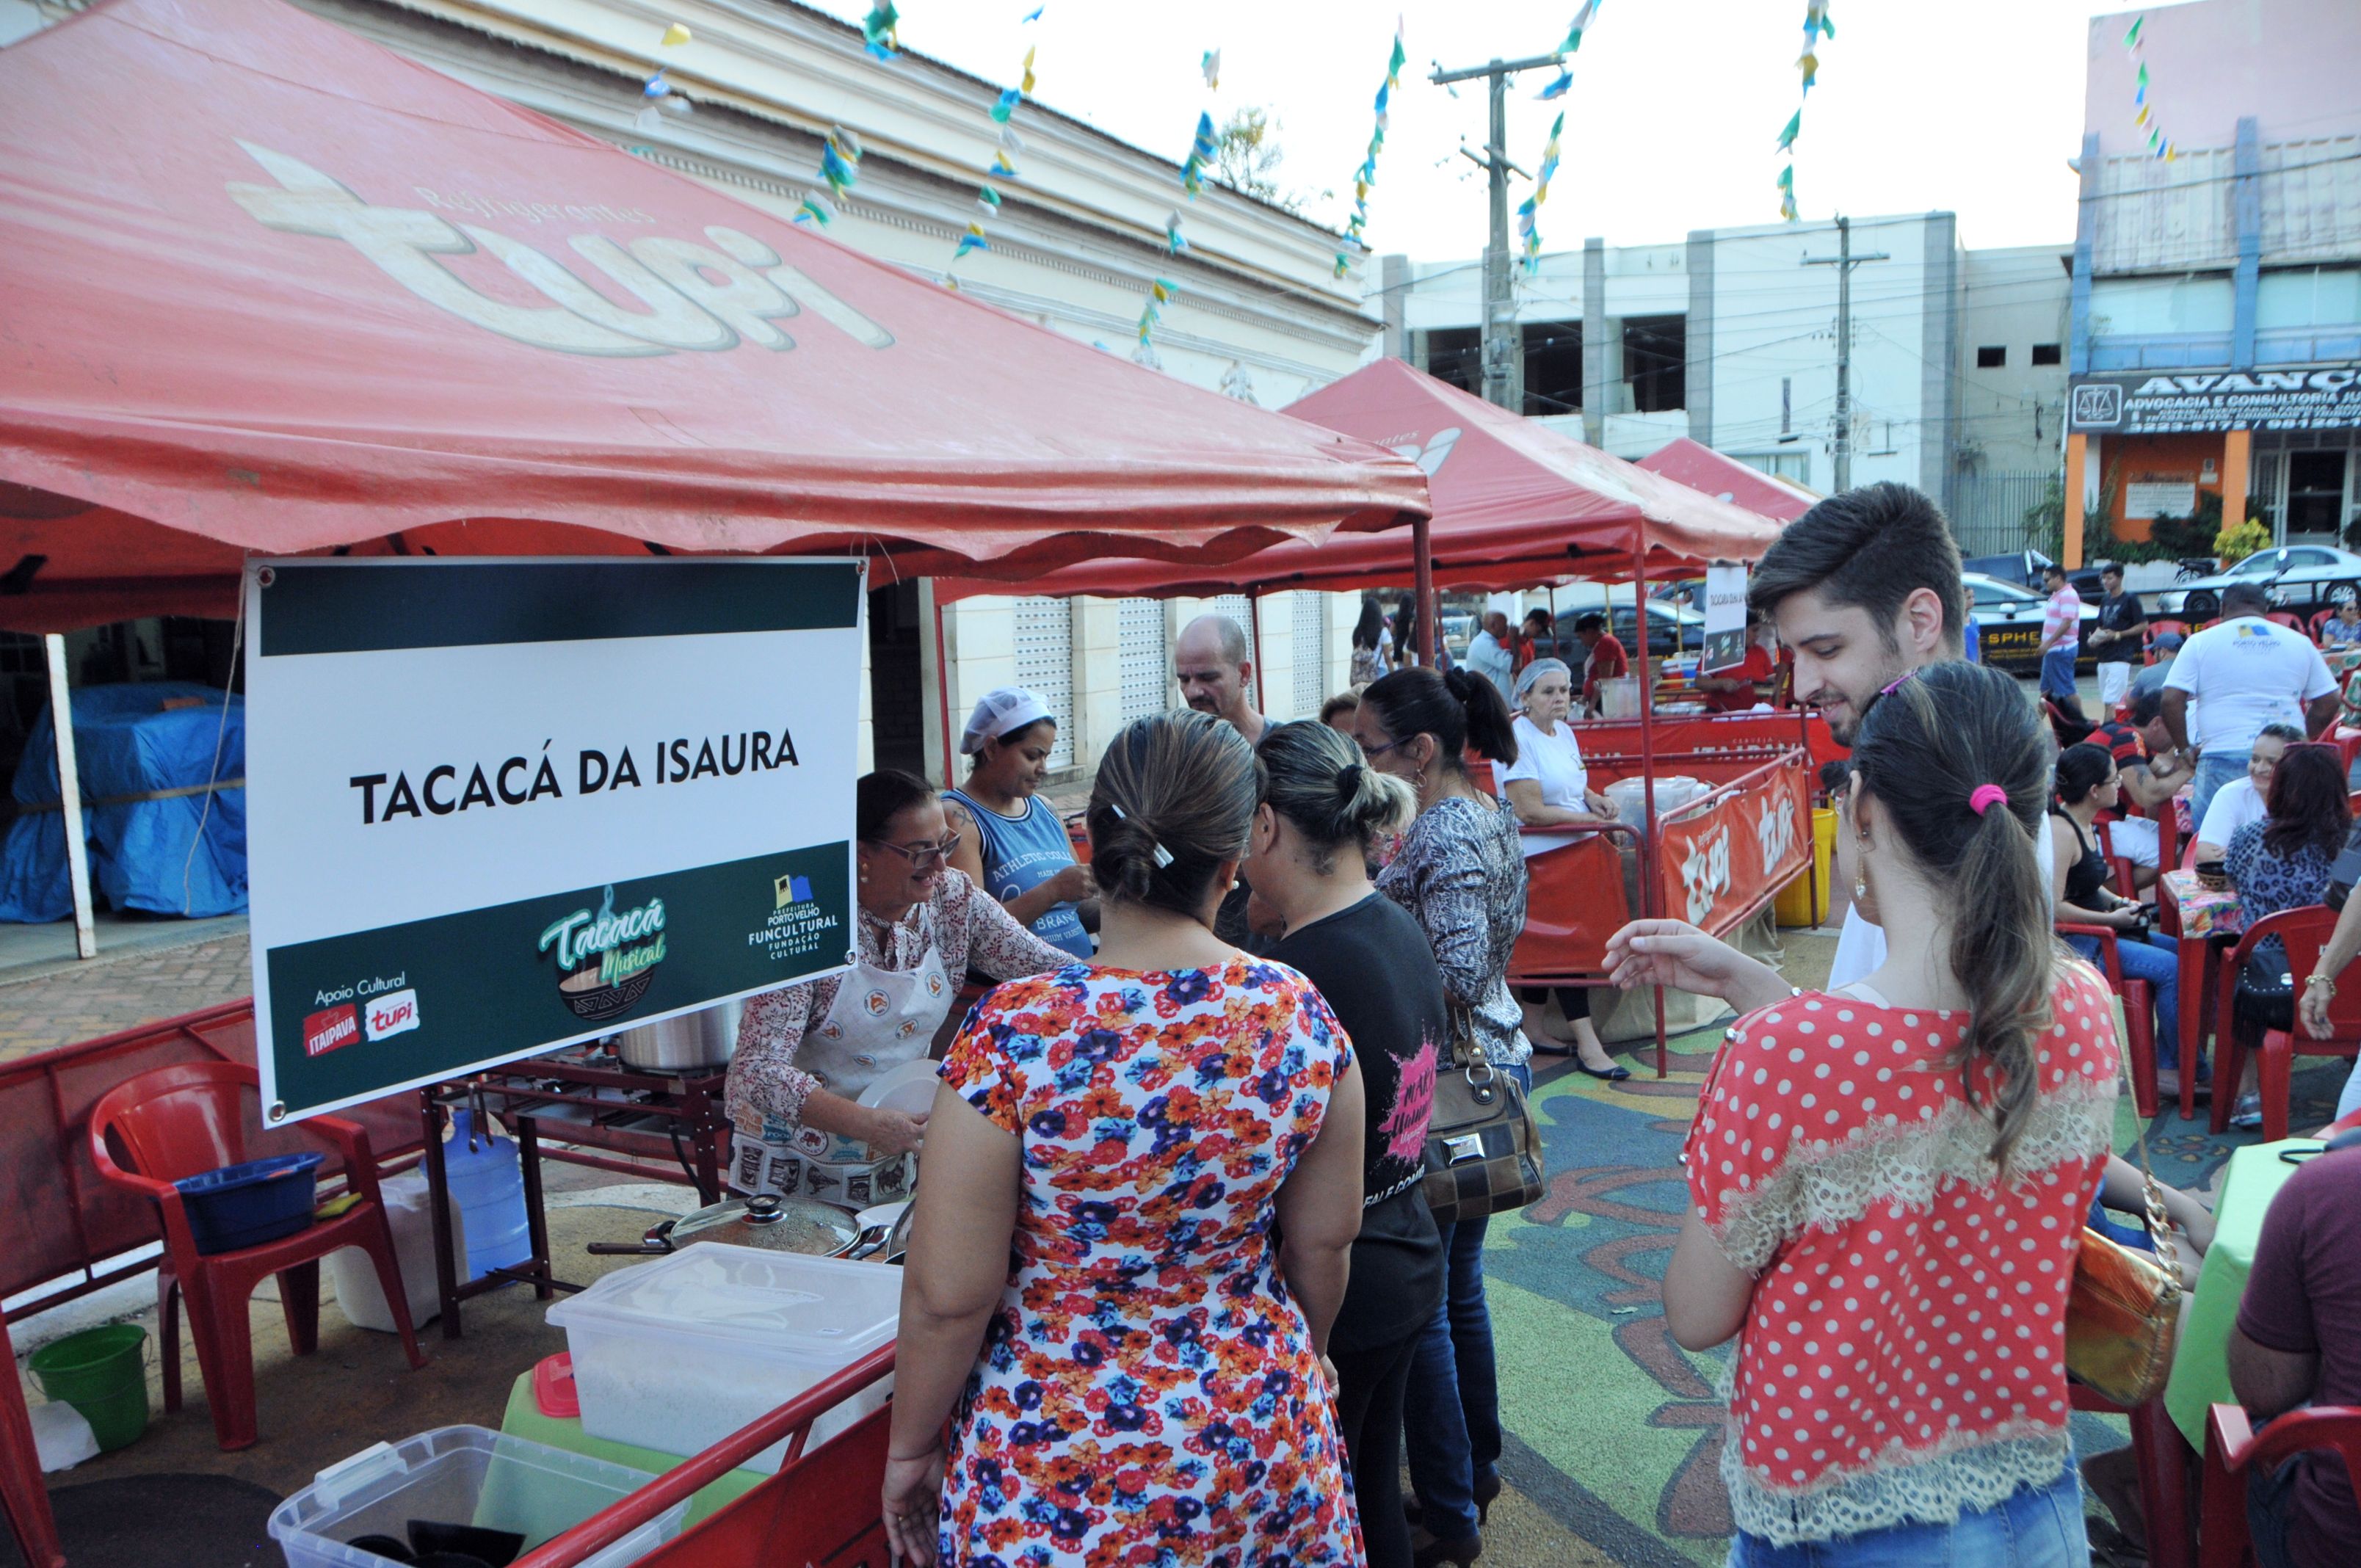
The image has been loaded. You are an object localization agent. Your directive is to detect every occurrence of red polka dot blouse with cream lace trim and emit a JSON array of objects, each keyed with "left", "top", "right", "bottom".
[{"left": 1683, "top": 963, "right": 2118, "bottom": 1545}]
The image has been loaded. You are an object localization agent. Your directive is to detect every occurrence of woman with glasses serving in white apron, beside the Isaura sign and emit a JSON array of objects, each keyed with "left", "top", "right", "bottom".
[{"left": 725, "top": 770, "right": 1072, "bottom": 1207}]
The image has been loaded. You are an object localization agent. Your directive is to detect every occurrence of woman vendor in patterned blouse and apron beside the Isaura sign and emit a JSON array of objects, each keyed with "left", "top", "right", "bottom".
[{"left": 725, "top": 770, "right": 1072, "bottom": 1202}]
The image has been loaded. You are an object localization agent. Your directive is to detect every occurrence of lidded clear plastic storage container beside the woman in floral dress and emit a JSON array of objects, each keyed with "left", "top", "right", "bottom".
[{"left": 550, "top": 1242, "right": 902, "bottom": 1473}]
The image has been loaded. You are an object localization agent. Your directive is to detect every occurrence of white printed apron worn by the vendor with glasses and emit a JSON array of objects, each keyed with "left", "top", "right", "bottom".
[{"left": 730, "top": 940, "right": 954, "bottom": 1209}]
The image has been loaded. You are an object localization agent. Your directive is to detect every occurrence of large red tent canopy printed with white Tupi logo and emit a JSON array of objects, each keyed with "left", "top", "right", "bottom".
[{"left": 0, "top": 0, "right": 1426, "bottom": 631}]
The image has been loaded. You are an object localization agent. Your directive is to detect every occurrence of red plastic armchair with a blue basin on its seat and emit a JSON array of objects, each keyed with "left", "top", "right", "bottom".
[{"left": 90, "top": 1063, "right": 427, "bottom": 1450}]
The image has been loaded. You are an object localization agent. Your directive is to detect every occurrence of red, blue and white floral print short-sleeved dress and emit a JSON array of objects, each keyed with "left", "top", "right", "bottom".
[{"left": 940, "top": 957, "right": 1363, "bottom": 1568}]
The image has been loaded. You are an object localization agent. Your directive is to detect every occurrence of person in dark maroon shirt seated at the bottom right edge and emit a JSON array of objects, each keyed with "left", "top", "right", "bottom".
[{"left": 2229, "top": 1147, "right": 2361, "bottom": 1568}]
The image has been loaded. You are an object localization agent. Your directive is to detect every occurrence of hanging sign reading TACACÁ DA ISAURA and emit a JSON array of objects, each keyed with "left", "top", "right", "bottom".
[{"left": 245, "top": 557, "right": 862, "bottom": 1122}]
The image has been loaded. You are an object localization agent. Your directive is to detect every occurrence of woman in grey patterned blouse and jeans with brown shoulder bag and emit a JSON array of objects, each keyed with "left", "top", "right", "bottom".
[{"left": 1353, "top": 668, "right": 1532, "bottom": 1566}]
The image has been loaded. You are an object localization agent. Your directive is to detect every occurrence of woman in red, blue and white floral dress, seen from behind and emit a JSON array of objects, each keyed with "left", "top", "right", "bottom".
[{"left": 883, "top": 711, "right": 1363, "bottom": 1568}]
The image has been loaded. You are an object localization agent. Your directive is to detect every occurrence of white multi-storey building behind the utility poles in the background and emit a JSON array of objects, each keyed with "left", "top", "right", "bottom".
[{"left": 1384, "top": 213, "right": 2068, "bottom": 548}]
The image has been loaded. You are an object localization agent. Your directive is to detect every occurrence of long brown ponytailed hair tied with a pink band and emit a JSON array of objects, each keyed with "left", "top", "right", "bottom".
[{"left": 1854, "top": 664, "right": 2059, "bottom": 1169}]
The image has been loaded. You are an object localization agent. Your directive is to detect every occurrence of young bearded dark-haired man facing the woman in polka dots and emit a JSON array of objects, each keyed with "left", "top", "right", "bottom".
[{"left": 1608, "top": 482, "right": 2056, "bottom": 1013}]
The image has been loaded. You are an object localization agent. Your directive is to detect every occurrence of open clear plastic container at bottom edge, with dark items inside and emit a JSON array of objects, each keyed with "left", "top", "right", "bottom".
[{"left": 272, "top": 1426, "right": 689, "bottom": 1568}]
